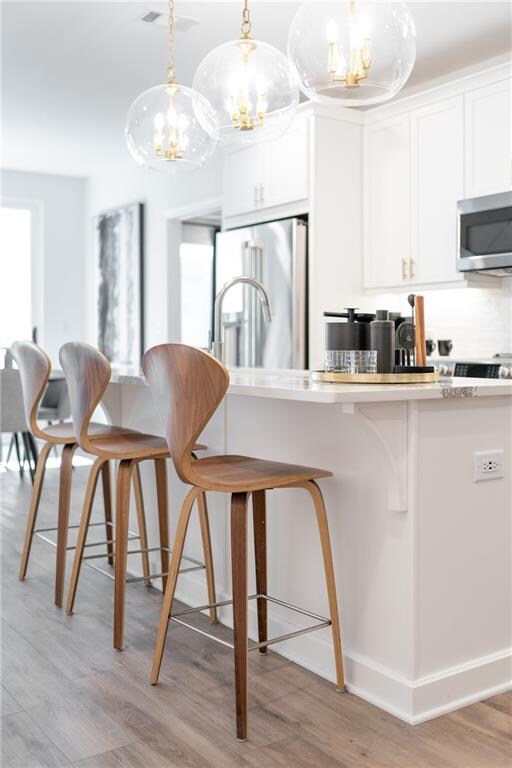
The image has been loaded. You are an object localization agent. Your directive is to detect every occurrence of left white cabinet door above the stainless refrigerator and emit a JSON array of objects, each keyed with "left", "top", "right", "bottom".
[{"left": 222, "top": 144, "right": 265, "bottom": 217}]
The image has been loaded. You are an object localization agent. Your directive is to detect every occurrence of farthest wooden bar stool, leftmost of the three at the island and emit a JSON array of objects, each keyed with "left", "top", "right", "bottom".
[{"left": 11, "top": 341, "right": 136, "bottom": 606}]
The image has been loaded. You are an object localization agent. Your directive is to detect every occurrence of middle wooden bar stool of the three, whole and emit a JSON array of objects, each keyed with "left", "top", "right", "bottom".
[{"left": 59, "top": 342, "right": 217, "bottom": 650}]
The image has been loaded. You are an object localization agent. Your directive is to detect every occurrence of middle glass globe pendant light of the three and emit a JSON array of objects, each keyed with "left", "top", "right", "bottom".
[{"left": 192, "top": 0, "right": 299, "bottom": 144}]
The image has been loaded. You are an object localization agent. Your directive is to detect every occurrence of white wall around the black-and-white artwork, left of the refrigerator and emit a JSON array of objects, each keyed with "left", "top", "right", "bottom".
[{"left": 87, "top": 156, "right": 222, "bottom": 349}]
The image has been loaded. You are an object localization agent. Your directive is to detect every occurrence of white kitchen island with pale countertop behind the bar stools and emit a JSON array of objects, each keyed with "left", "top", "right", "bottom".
[{"left": 105, "top": 370, "right": 512, "bottom": 724}]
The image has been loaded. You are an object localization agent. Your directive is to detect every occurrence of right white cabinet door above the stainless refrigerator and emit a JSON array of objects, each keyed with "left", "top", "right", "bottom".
[{"left": 262, "top": 119, "right": 308, "bottom": 208}]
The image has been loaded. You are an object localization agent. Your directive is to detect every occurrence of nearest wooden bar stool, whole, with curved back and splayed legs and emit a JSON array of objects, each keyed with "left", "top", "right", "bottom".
[{"left": 142, "top": 344, "right": 344, "bottom": 739}]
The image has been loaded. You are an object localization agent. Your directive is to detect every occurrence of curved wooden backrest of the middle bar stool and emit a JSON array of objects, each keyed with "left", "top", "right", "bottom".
[{"left": 59, "top": 341, "right": 112, "bottom": 451}]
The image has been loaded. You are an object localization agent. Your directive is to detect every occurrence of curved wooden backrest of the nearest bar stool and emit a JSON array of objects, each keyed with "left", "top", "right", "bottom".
[{"left": 142, "top": 344, "right": 229, "bottom": 484}]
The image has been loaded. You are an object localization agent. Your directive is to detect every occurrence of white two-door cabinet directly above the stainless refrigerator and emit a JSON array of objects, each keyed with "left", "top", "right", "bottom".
[{"left": 223, "top": 118, "right": 309, "bottom": 219}]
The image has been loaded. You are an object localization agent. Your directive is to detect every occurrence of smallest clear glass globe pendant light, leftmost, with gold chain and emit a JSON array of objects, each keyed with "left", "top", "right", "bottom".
[{"left": 125, "top": 0, "right": 217, "bottom": 173}]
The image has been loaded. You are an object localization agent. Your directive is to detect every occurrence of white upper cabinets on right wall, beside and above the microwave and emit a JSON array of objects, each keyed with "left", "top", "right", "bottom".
[{"left": 363, "top": 74, "right": 512, "bottom": 289}]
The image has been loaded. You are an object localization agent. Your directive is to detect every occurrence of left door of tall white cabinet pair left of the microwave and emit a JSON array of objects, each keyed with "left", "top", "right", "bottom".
[{"left": 362, "top": 115, "right": 410, "bottom": 288}]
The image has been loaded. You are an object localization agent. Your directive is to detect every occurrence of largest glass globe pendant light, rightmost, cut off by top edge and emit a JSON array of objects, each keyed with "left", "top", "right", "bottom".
[{"left": 288, "top": 0, "right": 416, "bottom": 107}]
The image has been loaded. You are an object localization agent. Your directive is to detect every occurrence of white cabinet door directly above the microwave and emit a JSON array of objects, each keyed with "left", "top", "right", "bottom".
[{"left": 465, "top": 80, "right": 512, "bottom": 197}]
